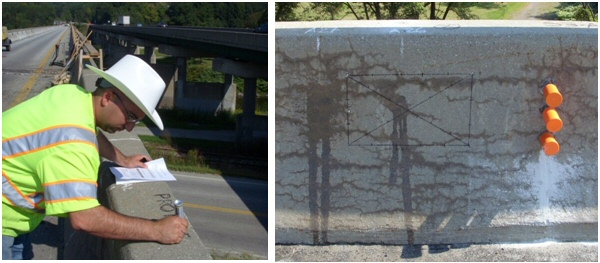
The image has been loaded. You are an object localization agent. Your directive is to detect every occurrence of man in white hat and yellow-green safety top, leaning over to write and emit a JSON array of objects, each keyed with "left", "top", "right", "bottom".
[{"left": 2, "top": 55, "right": 189, "bottom": 259}]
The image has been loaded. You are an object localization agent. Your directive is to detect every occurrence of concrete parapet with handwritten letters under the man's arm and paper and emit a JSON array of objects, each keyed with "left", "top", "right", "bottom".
[{"left": 64, "top": 162, "right": 212, "bottom": 260}]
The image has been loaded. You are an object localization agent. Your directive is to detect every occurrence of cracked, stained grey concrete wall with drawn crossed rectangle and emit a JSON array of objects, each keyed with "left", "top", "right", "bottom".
[{"left": 275, "top": 21, "right": 598, "bottom": 244}]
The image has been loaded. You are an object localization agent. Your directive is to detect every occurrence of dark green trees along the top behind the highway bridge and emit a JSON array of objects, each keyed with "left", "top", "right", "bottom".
[{"left": 2, "top": 2, "right": 268, "bottom": 29}]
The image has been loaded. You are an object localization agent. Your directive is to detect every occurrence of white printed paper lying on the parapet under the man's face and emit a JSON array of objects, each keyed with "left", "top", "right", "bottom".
[{"left": 110, "top": 158, "right": 177, "bottom": 184}]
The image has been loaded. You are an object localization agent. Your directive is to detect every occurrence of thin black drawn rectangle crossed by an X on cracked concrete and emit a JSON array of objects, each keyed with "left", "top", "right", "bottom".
[{"left": 346, "top": 73, "right": 474, "bottom": 147}]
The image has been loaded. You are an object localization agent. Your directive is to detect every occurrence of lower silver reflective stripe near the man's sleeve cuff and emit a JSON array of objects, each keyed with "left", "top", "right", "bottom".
[{"left": 44, "top": 180, "right": 98, "bottom": 204}]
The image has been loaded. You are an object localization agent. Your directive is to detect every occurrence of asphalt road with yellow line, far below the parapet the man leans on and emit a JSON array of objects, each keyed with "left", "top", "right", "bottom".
[{"left": 168, "top": 172, "right": 268, "bottom": 258}]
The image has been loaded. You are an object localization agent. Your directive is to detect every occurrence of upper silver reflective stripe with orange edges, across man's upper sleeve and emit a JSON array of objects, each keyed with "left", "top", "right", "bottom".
[{"left": 2, "top": 126, "right": 97, "bottom": 160}]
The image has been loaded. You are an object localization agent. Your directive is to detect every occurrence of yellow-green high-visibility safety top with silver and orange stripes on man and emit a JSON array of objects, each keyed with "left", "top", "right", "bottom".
[{"left": 2, "top": 84, "right": 100, "bottom": 237}]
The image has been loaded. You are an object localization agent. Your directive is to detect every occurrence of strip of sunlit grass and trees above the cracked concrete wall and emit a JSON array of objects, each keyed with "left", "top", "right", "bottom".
[{"left": 275, "top": 2, "right": 598, "bottom": 21}]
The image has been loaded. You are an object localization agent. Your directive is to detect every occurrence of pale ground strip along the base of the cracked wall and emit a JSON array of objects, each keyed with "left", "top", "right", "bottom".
[{"left": 275, "top": 240, "right": 598, "bottom": 262}]
